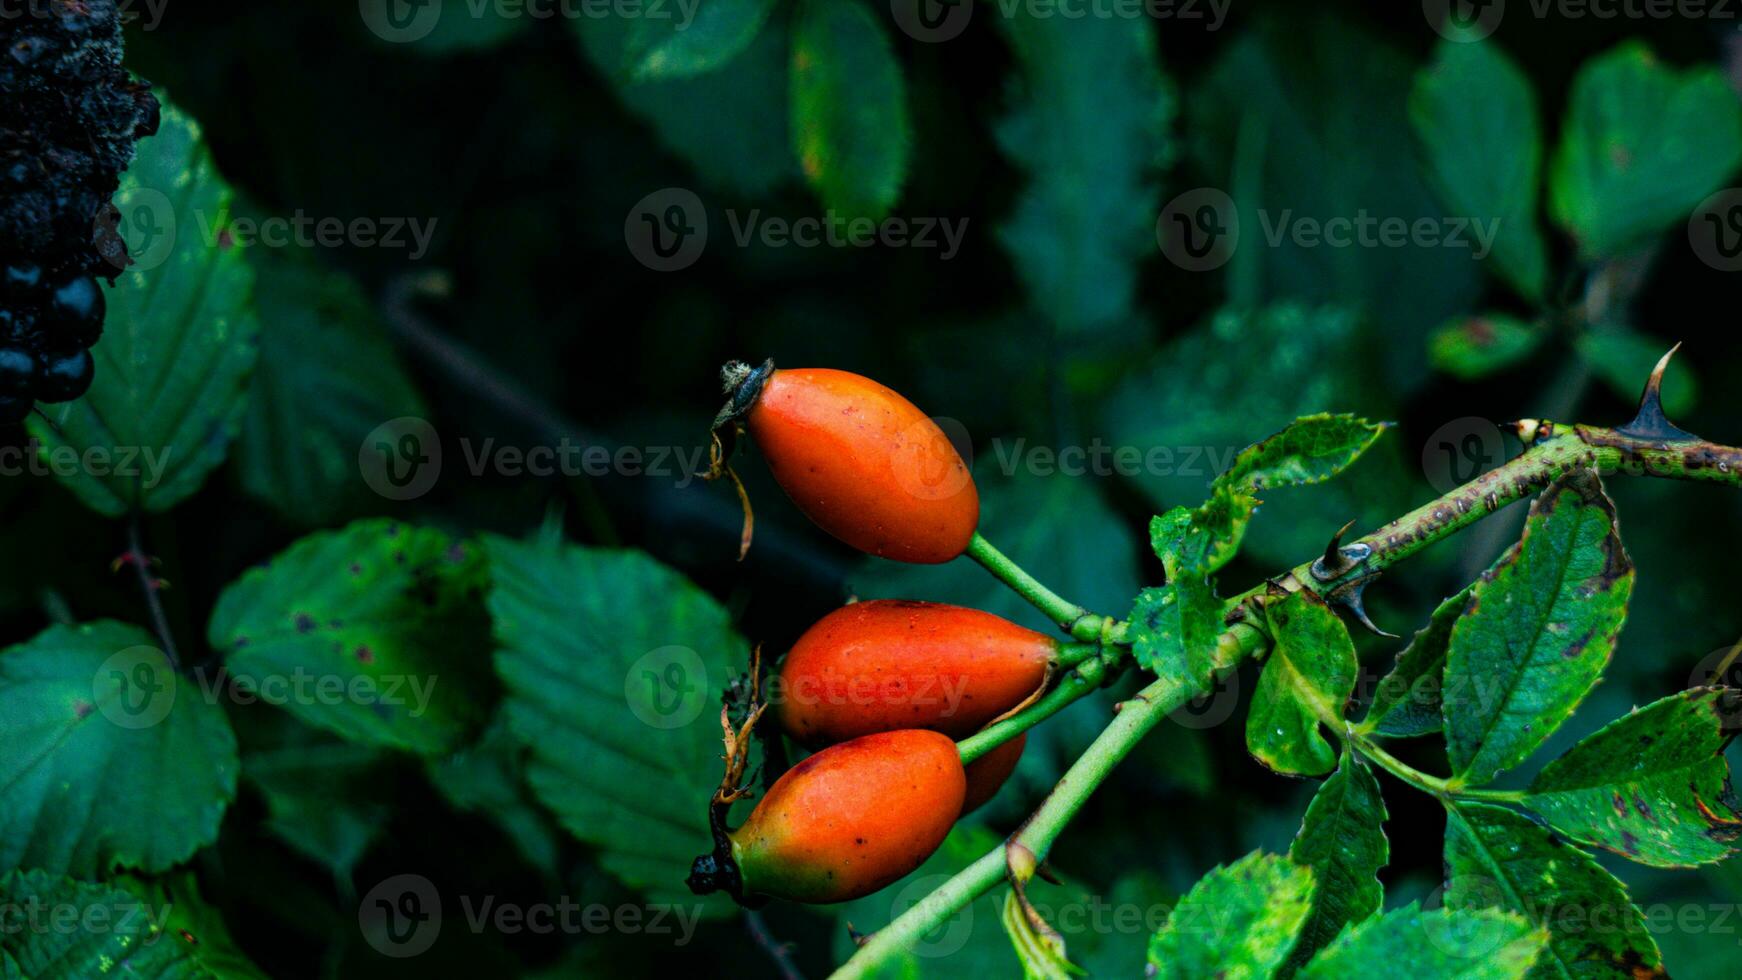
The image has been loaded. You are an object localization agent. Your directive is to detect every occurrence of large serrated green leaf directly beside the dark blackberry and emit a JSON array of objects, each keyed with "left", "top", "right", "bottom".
[{"left": 30, "top": 103, "right": 258, "bottom": 517}]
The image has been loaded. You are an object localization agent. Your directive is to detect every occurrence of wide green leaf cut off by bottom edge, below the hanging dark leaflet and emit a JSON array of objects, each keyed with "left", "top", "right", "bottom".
[{"left": 1296, "top": 905, "right": 1549, "bottom": 980}]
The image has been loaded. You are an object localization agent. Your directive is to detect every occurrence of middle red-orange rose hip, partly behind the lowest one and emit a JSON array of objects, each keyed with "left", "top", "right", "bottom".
[{"left": 773, "top": 599, "right": 1059, "bottom": 748}]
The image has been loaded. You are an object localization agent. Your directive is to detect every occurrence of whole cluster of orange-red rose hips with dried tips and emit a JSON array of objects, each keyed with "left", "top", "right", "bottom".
[{"left": 690, "top": 362, "right": 1061, "bottom": 903}]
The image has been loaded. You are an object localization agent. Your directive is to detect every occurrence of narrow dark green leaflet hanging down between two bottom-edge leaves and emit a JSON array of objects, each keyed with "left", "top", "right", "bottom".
[{"left": 1289, "top": 752, "right": 1392, "bottom": 966}]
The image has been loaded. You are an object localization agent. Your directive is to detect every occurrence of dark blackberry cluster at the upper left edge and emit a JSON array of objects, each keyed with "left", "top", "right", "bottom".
[{"left": 0, "top": 0, "right": 159, "bottom": 425}]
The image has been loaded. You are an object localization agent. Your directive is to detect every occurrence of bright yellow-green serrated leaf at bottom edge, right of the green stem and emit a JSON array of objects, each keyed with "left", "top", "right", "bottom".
[{"left": 1150, "top": 851, "right": 1313, "bottom": 980}]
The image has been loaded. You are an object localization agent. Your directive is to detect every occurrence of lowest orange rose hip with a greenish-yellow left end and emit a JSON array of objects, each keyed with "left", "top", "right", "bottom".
[{"left": 732, "top": 729, "right": 967, "bottom": 903}]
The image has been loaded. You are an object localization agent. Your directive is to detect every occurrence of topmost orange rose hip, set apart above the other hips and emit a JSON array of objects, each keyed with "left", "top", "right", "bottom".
[{"left": 746, "top": 367, "right": 979, "bottom": 564}]
